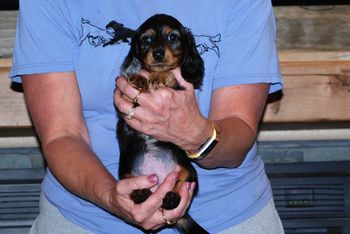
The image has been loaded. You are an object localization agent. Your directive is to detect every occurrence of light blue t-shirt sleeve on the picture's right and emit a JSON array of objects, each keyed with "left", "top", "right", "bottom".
[{"left": 213, "top": 0, "right": 282, "bottom": 93}]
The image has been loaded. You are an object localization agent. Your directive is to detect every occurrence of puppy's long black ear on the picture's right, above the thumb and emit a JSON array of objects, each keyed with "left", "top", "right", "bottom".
[{"left": 181, "top": 28, "right": 204, "bottom": 89}]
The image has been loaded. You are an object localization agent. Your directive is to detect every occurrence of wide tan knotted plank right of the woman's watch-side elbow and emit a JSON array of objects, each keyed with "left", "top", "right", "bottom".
[{"left": 263, "top": 61, "right": 350, "bottom": 123}]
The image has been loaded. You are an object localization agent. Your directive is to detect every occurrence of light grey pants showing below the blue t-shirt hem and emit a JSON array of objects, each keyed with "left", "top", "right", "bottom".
[{"left": 29, "top": 194, "right": 284, "bottom": 234}]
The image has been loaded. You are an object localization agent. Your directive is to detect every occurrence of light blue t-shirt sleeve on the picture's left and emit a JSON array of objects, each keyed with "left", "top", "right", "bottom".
[{"left": 10, "top": 0, "right": 78, "bottom": 82}]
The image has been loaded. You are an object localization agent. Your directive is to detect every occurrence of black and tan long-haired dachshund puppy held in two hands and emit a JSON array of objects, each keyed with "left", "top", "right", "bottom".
[{"left": 117, "top": 14, "right": 207, "bottom": 234}]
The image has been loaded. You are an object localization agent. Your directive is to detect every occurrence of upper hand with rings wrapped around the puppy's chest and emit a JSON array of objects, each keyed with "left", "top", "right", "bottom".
[{"left": 114, "top": 68, "right": 211, "bottom": 150}]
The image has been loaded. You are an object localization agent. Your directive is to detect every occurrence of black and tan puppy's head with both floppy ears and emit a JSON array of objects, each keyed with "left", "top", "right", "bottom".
[{"left": 123, "top": 14, "right": 204, "bottom": 88}]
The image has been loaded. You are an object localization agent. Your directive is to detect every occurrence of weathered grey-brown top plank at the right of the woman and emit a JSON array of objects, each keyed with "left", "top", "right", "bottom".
[{"left": 274, "top": 5, "right": 350, "bottom": 51}]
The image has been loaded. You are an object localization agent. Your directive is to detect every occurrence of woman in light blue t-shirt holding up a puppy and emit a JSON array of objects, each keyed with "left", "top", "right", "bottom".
[{"left": 10, "top": 0, "right": 283, "bottom": 234}]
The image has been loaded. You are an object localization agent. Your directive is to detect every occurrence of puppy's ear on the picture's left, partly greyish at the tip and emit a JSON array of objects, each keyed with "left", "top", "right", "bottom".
[{"left": 121, "top": 33, "right": 141, "bottom": 77}]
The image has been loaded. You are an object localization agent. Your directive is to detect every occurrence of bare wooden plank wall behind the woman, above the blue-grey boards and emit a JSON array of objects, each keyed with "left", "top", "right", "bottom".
[{"left": 0, "top": 5, "right": 350, "bottom": 145}]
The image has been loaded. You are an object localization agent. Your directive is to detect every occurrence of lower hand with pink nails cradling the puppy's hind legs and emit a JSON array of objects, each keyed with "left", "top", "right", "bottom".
[{"left": 107, "top": 172, "right": 195, "bottom": 230}]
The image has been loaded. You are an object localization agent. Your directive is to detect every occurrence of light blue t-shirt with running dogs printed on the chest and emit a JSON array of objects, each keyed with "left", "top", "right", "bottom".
[{"left": 10, "top": 0, "right": 282, "bottom": 234}]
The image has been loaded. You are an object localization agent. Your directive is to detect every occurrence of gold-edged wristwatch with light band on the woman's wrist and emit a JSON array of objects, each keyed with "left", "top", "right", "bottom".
[{"left": 186, "top": 122, "right": 220, "bottom": 160}]
